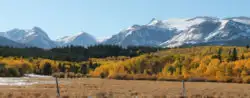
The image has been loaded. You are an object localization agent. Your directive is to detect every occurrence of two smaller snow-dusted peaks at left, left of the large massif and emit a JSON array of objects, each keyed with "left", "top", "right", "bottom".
[{"left": 0, "top": 27, "right": 97, "bottom": 49}]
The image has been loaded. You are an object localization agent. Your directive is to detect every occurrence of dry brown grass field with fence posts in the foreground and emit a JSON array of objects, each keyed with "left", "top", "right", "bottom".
[{"left": 0, "top": 78, "right": 250, "bottom": 98}]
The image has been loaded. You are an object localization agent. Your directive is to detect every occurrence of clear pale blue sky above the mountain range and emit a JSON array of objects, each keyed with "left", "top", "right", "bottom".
[{"left": 0, "top": 0, "right": 250, "bottom": 39}]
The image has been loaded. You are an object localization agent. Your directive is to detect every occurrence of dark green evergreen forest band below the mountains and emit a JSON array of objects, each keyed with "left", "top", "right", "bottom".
[{"left": 0, "top": 45, "right": 160, "bottom": 62}]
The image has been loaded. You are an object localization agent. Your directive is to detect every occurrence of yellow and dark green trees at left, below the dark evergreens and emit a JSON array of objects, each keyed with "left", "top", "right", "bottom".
[{"left": 0, "top": 57, "right": 100, "bottom": 78}]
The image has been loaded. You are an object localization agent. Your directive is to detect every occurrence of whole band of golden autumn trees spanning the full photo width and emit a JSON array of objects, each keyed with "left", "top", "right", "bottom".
[{"left": 0, "top": 46, "right": 250, "bottom": 83}]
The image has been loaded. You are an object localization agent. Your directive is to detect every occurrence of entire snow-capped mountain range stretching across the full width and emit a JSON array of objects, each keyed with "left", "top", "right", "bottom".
[{"left": 0, "top": 16, "right": 250, "bottom": 48}]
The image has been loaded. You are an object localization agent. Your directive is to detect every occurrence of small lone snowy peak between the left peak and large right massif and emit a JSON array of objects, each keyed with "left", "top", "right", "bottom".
[{"left": 56, "top": 32, "right": 97, "bottom": 47}]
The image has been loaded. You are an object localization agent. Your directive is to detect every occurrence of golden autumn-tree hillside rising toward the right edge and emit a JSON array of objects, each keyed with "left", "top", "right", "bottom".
[{"left": 91, "top": 46, "right": 250, "bottom": 82}]
